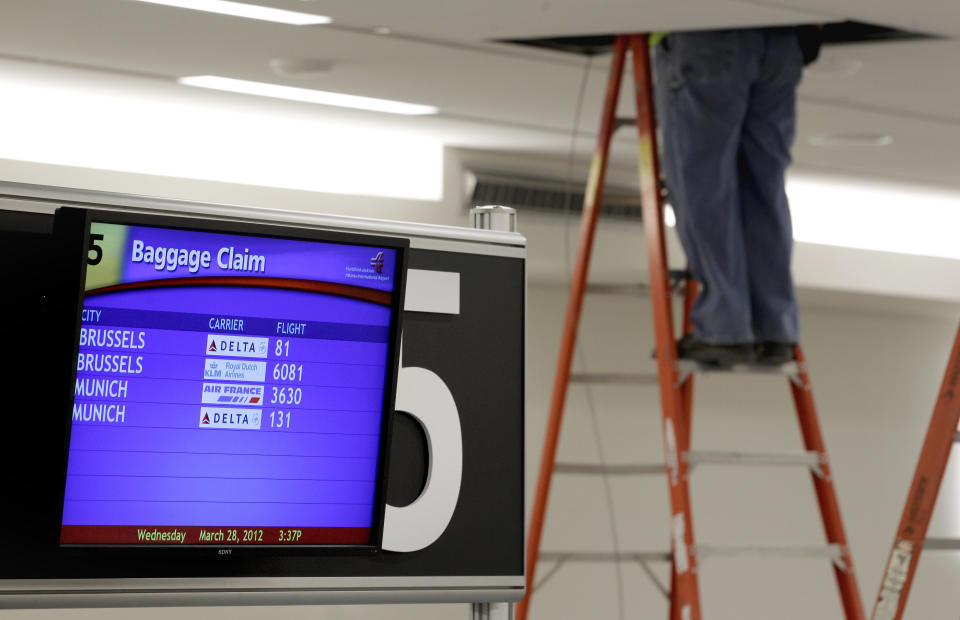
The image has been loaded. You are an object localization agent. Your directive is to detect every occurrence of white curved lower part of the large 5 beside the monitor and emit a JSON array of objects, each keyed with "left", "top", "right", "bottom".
[{"left": 383, "top": 343, "right": 463, "bottom": 552}]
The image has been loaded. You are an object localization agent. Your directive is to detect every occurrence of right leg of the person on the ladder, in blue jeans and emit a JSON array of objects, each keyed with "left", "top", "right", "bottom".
[{"left": 739, "top": 30, "right": 803, "bottom": 348}]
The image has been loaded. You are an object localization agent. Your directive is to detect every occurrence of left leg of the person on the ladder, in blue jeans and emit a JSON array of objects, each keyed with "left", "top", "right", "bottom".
[{"left": 656, "top": 31, "right": 762, "bottom": 345}]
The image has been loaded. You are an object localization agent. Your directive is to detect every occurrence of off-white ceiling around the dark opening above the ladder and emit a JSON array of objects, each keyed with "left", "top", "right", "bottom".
[{"left": 0, "top": 0, "right": 960, "bottom": 187}]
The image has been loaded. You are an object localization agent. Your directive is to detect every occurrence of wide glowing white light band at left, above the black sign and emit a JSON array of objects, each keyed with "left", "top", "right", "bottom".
[{"left": 0, "top": 59, "right": 444, "bottom": 200}]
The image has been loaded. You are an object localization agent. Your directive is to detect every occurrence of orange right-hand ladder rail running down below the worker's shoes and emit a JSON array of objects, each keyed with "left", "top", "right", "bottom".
[{"left": 788, "top": 346, "right": 866, "bottom": 620}]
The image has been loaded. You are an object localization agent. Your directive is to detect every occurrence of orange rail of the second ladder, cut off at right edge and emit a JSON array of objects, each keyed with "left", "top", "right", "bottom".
[{"left": 872, "top": 328, "right": 960, "bottom": 620}]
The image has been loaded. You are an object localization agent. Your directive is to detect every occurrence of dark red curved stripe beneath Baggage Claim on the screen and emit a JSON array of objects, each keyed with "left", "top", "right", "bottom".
[{"left": 86, "top": 276, "right": 393, "bottom": 306}]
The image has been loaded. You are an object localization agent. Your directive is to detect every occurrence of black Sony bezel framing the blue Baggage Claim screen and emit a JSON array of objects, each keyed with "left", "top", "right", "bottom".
[{"left": 53, "top": 207, "right": 410, "bottom": 560}]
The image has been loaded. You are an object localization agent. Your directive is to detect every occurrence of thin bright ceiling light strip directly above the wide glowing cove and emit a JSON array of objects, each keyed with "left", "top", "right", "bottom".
[{"left": 178, "top": 75, "right": 437, "bottom": 115}]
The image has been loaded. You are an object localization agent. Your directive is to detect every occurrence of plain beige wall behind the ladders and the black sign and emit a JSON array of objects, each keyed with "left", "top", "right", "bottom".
[{"left": 0, "top": 150, "right": 960, "bottom": 620}]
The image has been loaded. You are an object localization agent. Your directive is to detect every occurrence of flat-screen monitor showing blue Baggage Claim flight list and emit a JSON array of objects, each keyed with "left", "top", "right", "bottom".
[{"left": 60, "top": 210, "right": 408, "bottom": 548}]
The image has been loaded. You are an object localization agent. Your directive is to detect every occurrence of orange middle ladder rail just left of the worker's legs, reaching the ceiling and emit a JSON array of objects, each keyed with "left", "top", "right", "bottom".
[{"left": 630, "top": 35, "right": 701, "bottom": 620}]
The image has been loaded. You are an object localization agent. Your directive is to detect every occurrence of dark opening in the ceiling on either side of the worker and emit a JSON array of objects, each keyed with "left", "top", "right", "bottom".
[{"left": 502, "top": 21, "right": 937, "bottom": 56}]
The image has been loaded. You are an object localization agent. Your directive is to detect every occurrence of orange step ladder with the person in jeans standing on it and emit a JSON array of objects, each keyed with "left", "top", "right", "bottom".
[{"left": 517, "top": 34, "right": 865, "bottom": 620}]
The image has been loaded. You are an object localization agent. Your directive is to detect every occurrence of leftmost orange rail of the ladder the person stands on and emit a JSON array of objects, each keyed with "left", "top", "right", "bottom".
[{"left": 516, "top": 36, "right": 627, "bottom": 620}]
